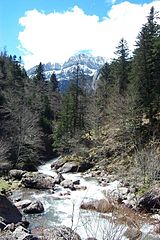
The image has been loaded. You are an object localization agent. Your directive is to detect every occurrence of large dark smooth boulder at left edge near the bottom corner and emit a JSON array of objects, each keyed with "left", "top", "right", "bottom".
[{"left": 0, "top": 194, "right": 22, "bottom": 224}]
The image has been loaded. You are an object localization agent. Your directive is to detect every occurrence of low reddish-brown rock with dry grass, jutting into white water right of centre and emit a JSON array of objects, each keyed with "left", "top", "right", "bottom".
[{"left": 80, "top": 199, "right": 114, "bottom": 213}]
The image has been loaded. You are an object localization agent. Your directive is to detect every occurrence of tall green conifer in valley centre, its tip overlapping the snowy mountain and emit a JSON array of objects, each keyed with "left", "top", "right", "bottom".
[{"left": 54, "top": 65, "right": 86, "bottom": 144}]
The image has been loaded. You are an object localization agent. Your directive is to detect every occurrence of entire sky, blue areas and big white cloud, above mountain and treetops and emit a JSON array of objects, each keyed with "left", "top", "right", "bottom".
[{"left": 0, "top": 0, "right": 160, "bottom": 68}]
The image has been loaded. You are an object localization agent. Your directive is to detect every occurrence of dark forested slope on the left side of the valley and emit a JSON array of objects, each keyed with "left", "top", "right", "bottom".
[{"left": 0, "top": 52, "right": 60, "bottom": 170}]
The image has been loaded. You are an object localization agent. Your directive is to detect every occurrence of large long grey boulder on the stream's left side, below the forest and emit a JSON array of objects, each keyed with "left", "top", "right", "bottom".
[{"left": 22, "top": 172, "right": 55, "bottom": 189}]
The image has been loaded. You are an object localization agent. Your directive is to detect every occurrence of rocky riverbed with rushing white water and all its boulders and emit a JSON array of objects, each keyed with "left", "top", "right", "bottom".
[{"left": 0, "top": 159, "right": 160, "bottom": 240}]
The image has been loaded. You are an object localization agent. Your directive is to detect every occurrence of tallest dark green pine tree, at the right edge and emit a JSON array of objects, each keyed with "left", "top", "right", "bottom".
[{"left": 134, "top": 7, "right": 160, "bottom": 125}]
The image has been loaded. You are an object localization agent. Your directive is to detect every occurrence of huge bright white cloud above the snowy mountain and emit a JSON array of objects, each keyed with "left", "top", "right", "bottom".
[{"left": 19, "top": 1, "right": 160, "bottom": 68}]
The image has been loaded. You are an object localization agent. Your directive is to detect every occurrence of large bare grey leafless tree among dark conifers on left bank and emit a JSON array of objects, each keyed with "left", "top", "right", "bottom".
[{"left": 6, "top": 91, "right": 42, "bottom": 168}]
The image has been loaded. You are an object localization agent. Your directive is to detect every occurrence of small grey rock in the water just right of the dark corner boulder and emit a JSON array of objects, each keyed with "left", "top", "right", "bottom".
[{"left": 23, "top": 201, "right": 44, "bottom": 214}]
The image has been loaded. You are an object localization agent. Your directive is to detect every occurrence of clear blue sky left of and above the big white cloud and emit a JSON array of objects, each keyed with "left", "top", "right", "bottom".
[{"left": 0, "top": 0, "right": 110, "bottom": 54}]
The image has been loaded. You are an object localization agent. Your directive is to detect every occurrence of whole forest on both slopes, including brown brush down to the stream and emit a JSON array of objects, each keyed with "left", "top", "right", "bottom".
[{"left": 0, "top": 7, "right": 160, "bottom": 184}]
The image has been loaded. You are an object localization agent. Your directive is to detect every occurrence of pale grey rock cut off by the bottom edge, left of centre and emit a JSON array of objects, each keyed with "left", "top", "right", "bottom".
[{"left": 35, "top": 226, "right": 81, "bottom": 240}]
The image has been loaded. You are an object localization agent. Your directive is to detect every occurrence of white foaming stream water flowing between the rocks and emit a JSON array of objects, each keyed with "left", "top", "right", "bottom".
[{"left": 13, "top": 159, "right": 159, "bottom": 240}]
